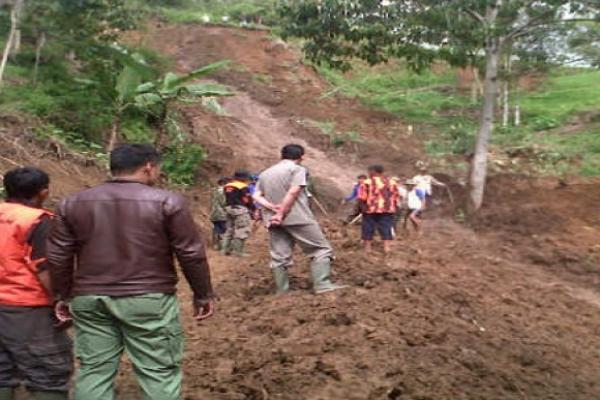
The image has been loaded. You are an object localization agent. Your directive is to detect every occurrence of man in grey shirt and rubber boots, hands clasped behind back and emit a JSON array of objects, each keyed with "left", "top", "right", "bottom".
[{"left": 254, "top": 144, "right": 345, "bottom": 293}]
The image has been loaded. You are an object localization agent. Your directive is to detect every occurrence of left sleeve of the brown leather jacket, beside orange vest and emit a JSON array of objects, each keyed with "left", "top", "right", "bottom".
[{"left": 46, "top": 201, "right": 77, "bottom": 300}]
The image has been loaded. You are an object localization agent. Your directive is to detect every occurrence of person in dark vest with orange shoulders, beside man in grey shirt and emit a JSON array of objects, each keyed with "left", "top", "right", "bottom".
[{"left": 221, "top": 171, "right": 254, "bottom": 257}]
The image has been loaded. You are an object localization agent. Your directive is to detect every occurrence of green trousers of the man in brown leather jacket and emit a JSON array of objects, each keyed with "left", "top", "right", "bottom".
[{"left": 71, "top": 293, "right": 183, "bottom": 400}]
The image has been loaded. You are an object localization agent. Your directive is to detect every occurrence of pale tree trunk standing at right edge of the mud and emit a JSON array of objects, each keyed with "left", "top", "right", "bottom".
[{"left": 469, "top": 38, "right": 500, "bottom": 211}]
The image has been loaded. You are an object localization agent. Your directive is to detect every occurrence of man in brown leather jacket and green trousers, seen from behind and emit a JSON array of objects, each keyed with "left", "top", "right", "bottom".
[{"left": 47, "top": 144, "right": 214, "bottom": 400}]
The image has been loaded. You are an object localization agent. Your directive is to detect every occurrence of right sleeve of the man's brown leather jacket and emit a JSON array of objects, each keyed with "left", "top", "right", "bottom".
[{"left": 165, "top": 195, "right": 215, "bottom": 303}]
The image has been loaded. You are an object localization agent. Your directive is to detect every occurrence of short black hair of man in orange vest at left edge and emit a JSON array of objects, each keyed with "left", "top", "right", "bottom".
[{"left": 4, "top": 167, "right": 50, "bottom": 200}]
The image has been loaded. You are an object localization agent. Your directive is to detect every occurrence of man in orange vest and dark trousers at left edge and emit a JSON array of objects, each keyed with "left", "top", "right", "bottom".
[{"left": 0, "top": 167, "right": 73, "bottom": 400}]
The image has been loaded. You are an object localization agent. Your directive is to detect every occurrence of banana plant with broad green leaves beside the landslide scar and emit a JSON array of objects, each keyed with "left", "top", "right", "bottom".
[{"left": 133, "top": 61, "right": 232, "bottom": 148}]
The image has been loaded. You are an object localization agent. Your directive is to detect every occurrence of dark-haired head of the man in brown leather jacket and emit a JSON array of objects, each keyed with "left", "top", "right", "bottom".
[{"left": 110, "top": 144, "right": 160, "bottom": 185}]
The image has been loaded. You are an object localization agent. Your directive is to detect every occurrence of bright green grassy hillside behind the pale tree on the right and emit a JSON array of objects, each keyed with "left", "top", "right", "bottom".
[{"left": 317, "top": 62, "right": 600, "bottom": 176}]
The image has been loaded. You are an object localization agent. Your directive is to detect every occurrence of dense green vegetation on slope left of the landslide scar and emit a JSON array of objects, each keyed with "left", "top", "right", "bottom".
[{"left": 0, "top": 0, "right": 227, "bottom": 184}]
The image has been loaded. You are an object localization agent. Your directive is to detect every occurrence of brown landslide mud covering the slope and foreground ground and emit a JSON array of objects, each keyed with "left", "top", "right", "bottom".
[{"left": 0, "top": 25, "right": 600, "bottom": 400}]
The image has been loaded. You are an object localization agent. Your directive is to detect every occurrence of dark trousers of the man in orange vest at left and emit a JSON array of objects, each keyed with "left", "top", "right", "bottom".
[{"left": 0, "top": 305, "right": 73, "bottom": 392}]
